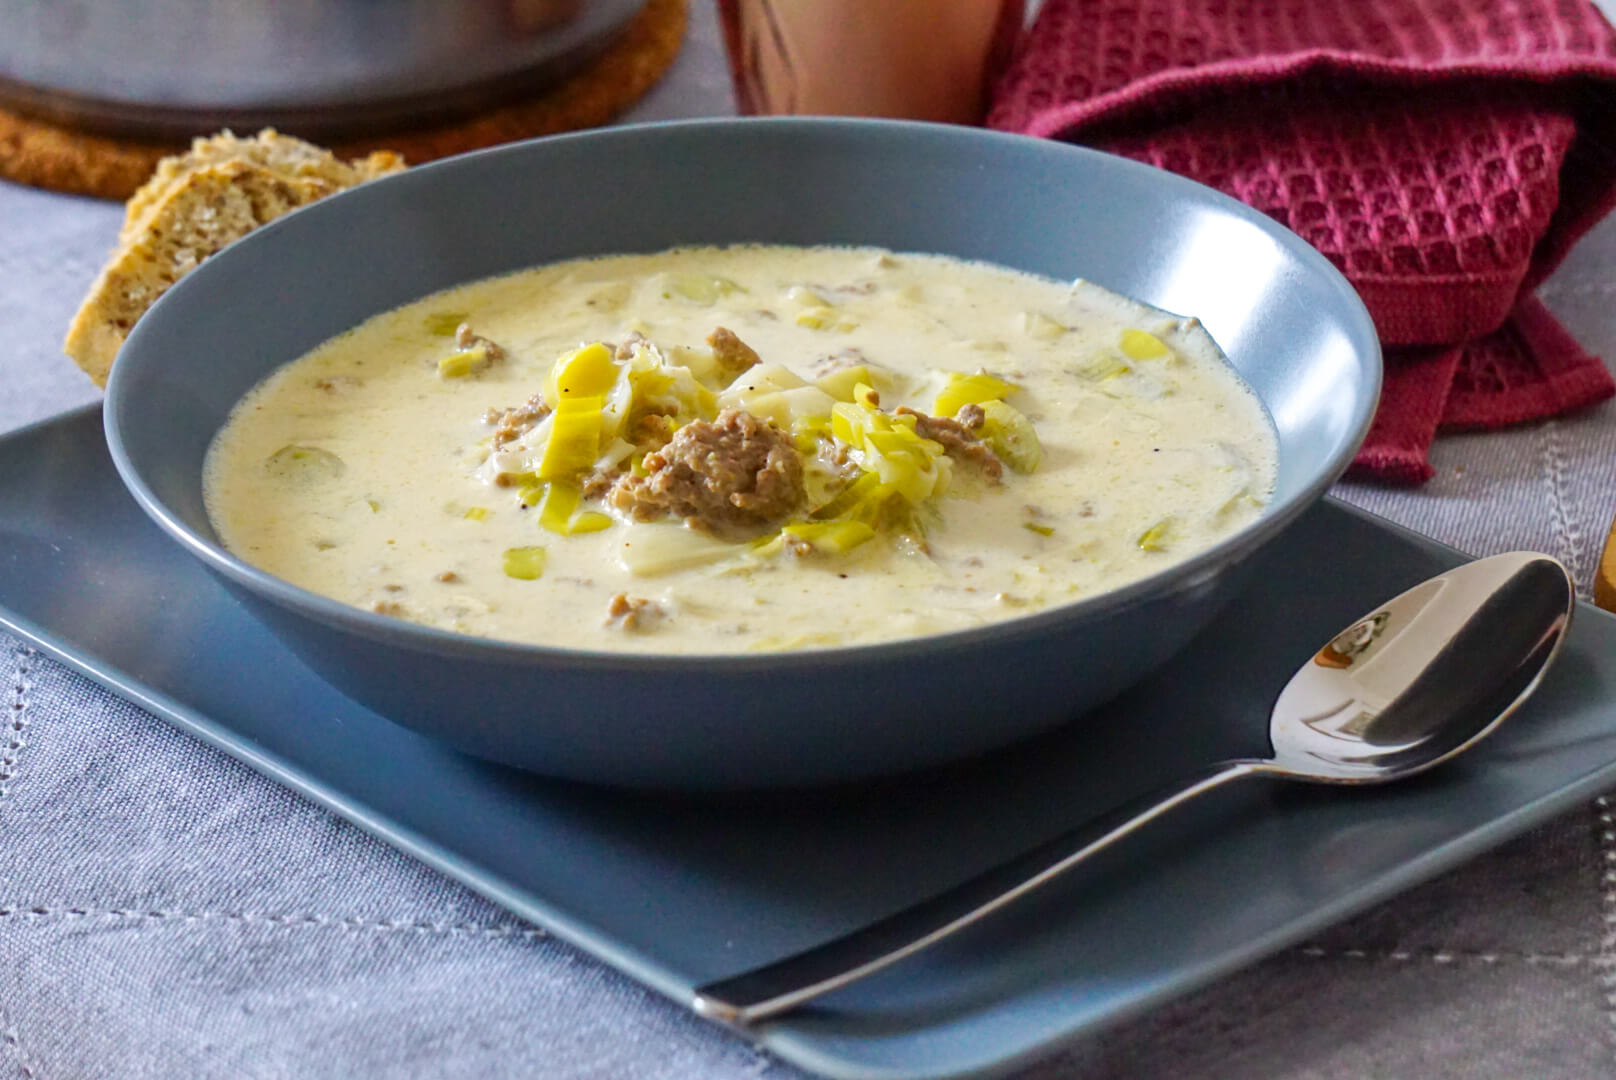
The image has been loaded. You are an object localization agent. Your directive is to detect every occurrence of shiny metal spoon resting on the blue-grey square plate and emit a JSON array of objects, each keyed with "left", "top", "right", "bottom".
[{"left": 693, "top": 551, "right": 1576, "bottom": 1025}]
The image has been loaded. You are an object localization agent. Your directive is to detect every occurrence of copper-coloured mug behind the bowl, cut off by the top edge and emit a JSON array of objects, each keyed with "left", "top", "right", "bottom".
[{"left": 718, "top": 0, "right": 1026, "bottom": 124}]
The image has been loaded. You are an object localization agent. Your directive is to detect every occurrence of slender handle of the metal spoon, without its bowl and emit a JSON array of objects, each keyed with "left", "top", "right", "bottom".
[{"left": 693, "top": 761, "right": 1264, "bottom": 1025}]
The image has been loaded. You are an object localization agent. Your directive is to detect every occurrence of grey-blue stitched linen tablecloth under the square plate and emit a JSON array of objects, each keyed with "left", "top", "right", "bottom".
[{"left": 0, "top": 3, "right": 1616, "bottom": 1080}]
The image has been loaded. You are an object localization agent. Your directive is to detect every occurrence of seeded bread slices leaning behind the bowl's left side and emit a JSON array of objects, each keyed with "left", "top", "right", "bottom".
[{"left": 61, "top": 129, "right": 404, "bottom": 386}]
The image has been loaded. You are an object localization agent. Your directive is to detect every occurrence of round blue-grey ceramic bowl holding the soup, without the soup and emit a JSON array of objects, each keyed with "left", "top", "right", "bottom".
[{"left": 105, "top": 120, "right": 1380, "bottom": 789}]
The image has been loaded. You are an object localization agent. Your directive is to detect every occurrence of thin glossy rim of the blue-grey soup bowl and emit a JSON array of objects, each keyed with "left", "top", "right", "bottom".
[{"left": 102, "top": 116, "right": 1383, "bottom": 674}]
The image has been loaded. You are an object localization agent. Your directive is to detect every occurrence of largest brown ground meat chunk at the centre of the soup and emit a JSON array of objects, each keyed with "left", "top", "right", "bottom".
[{"left": 608, "top": 409, "right": 805, "bottom": 534}]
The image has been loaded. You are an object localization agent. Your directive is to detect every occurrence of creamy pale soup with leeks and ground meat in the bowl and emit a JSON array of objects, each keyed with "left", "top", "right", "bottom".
[{"left": 205, "top": 246, "right": 1275, "bottom": 653}]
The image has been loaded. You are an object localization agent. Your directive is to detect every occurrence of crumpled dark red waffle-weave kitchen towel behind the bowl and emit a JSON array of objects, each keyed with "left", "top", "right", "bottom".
[{"left": 987, "top": 0, "right": 1616, "bottom": 483}]
